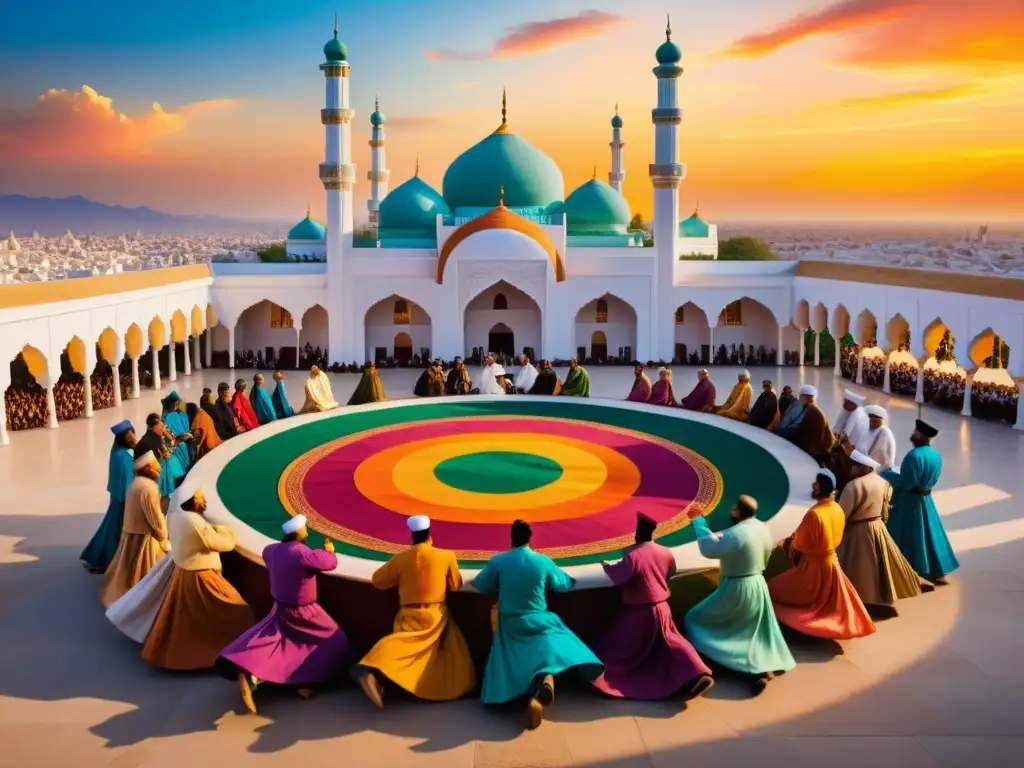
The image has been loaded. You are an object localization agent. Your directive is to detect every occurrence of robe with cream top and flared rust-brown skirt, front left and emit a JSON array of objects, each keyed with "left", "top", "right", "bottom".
[{"left": 142, "top": 509, "right": 256, "bottom": 671}]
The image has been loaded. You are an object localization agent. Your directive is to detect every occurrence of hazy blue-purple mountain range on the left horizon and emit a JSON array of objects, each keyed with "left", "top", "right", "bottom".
[{"left": 0, "top": 195, "right": 288, "bottom": 238}]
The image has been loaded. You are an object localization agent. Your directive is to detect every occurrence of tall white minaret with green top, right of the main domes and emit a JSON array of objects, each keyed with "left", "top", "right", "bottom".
[{"left": 649, "top": 13, "right": 686, "bottom": 360}]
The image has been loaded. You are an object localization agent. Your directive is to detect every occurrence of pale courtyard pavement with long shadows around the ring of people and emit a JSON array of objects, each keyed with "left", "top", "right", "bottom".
[{"left": 0, "top": 368, "right": 1024, "bottom": 768}]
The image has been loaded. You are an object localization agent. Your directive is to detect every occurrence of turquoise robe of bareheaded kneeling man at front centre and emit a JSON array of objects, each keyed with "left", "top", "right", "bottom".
[{"left": 473, "top": 547, "right": 604, "bottom": 703}]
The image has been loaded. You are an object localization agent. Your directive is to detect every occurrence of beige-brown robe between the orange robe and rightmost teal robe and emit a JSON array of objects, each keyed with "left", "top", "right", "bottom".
[{"left": 836, "top": 472, "right": 922, "bottom": 606}]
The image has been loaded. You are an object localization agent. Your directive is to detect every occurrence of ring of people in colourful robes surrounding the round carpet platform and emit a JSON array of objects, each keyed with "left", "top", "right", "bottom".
[{"left": 74, "top": 356, "right": 958, "bottom": 728}]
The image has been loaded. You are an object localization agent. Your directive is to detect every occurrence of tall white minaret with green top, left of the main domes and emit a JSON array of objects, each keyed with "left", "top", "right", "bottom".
[{"left": 319, "top": 14, "right": 364, "bottom": 362}]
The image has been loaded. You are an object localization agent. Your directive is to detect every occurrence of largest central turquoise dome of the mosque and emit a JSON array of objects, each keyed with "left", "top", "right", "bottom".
[{"left": 441, "top": 128, "right": 565, "bottom": 210}]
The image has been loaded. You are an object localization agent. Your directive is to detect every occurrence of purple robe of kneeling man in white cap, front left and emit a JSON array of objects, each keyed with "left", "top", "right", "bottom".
[{"left": 218, "top": 542, "right": 349, "bottom": 685}]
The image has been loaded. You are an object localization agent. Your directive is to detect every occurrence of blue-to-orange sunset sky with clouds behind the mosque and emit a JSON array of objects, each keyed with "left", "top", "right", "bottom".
[{"left": 0, "top": 0, "right": 1024, "bottom": 221}]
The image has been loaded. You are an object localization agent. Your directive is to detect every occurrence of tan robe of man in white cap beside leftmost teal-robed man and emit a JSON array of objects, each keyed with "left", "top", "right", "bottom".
[{"left": 99, "top": 475, "right": 171, "bottom": 608}]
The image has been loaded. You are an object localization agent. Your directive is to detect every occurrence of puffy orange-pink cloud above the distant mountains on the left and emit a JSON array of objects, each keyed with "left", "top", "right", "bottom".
[{"left": 0, "top": 85, "right": 237, "bottom": 161}]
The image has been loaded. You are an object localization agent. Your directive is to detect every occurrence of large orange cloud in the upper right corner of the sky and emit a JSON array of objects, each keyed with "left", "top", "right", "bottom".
[{"left": 723, "top": 0, "right": 1024, "bottom": 69}]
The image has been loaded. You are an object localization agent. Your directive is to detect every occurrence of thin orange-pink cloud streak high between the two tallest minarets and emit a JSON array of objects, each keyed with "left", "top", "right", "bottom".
[{"left": 423, "top": 10, "right": 627, "bottom": 61}]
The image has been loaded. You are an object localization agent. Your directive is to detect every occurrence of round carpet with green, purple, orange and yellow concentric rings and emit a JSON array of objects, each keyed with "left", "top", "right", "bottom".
[{"left": 217, "top": 397, "right": 788, "bottom": 566}]
